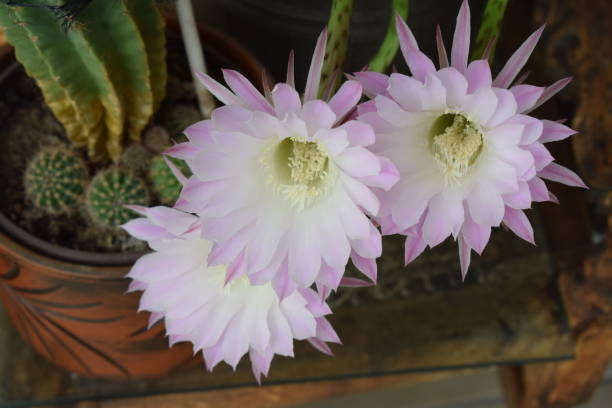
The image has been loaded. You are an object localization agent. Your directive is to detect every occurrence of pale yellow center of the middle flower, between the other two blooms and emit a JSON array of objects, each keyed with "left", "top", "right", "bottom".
[{"left": 261, "top": 137, "right": 335, "bottom": 210}]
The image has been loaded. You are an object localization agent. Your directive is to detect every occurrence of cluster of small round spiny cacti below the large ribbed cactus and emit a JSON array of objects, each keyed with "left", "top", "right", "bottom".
[{"left": 24, "top": 147, "right": 189, "bottom": 228}]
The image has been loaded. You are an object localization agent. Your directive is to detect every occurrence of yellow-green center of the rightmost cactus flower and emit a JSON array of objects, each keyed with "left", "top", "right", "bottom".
[{"left": 430, "top": 113, "right": 482, "bottom": 184}]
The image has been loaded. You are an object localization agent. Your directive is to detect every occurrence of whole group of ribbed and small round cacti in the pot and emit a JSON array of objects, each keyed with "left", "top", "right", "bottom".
[{"left": 0, "top": 0, "right": 194, "bottom": 228}]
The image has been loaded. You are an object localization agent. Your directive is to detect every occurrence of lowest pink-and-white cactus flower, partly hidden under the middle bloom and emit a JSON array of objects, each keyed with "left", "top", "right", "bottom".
[{"left": 123, "top": 206, "right": 340, "bottom": 382}]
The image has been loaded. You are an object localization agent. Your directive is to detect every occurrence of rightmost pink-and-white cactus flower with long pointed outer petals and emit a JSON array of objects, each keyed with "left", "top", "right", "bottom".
[{"left": 355, "top": 1, "right": 585, "bottom": 277}]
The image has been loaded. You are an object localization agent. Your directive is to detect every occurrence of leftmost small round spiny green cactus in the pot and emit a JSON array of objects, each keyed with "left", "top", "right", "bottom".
[{"left": 24, "top": 147, "right": 87, "bottom": 215}]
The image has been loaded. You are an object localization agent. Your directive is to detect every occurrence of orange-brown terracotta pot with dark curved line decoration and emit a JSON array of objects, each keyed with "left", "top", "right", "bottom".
[{"left": 0, "top": 21, "right": 263, "bottom": 378}]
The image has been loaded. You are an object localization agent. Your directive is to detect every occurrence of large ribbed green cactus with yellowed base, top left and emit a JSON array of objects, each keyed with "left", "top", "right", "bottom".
[{"left": 0, "top": 0, "right": 166, "bottom": 161}]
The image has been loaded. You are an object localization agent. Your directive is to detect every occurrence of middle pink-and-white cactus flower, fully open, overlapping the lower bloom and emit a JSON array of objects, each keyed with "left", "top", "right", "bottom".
[{"left": 166, "top": 31, "right": 398, "bottom": 298}]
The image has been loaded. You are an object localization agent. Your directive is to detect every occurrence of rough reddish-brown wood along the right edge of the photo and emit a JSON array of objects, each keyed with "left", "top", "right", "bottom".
[{"left": 504, "top": 0, "right": 612, "bottom": 408}]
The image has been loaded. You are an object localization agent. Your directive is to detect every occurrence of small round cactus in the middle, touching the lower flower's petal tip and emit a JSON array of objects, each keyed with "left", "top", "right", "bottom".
[{"left": 85, "top": 167, "right": 149, "bottom": 228}]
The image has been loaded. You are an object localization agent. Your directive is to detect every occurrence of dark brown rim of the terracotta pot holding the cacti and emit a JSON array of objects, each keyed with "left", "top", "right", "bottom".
[{"left": 0, "top": 18, "right": 267, "bottom": 270}]
